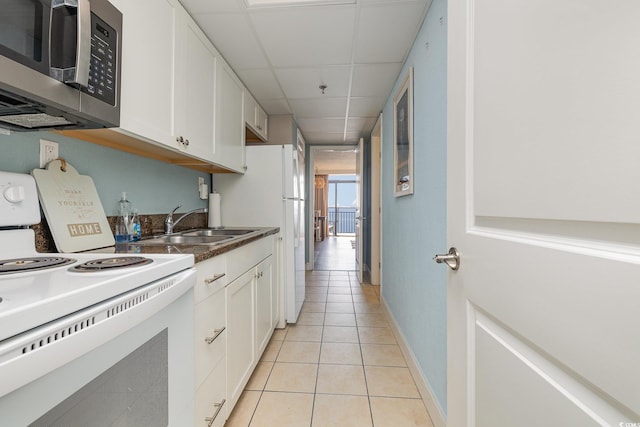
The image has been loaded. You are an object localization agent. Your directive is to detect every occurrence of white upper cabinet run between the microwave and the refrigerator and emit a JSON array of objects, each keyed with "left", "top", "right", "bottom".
[{"left": 108, "top": 0, "right": 244, "bottom": 172}]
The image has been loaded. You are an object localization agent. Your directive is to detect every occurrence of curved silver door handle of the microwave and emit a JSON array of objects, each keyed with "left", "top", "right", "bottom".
[{"left": 49, "top": 0, "right": 91, "bottom": 87}]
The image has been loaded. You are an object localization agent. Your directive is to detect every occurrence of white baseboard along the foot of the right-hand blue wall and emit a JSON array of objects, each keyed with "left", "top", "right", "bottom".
[{"left": 380, "top": 295, "right": 447, "bottom": 427}]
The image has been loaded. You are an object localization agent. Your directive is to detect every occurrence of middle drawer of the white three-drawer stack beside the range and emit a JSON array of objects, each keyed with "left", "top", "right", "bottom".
[{"left": 194, "top": 289, "right": 227, "bottom": 387}]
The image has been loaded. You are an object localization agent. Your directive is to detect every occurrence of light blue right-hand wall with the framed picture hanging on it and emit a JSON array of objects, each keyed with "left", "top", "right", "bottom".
[{"left": 382, "top": 0, "right": 447, "bottom": 414}]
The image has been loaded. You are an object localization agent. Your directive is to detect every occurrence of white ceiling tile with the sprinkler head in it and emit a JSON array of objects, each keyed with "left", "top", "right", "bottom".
[{"left": 275, "top": 66, "right": 350, "bottom": 98}]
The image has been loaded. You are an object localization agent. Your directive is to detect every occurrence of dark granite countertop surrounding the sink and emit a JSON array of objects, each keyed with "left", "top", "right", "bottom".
[{"left": 89, "top": 227, "right": 280, "bottom": 263}]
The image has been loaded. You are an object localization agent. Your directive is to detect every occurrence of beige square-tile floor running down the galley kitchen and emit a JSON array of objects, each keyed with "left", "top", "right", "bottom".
[{"left": 226, "top": 271, "right": 432, "bottom": 427}]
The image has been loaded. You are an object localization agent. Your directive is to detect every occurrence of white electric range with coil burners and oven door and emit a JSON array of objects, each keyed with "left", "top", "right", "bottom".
[{"left": 0, "top": 172, "right": 195, "bottom": 425}]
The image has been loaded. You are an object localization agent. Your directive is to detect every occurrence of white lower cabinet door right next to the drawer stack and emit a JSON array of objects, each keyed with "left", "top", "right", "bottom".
[{"left": 226, "top": 268, "right": 255, "bottom": 408}]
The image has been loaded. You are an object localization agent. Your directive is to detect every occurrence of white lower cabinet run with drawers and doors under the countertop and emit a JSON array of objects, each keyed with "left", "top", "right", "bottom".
[{"left": 194, "top": 236, "right": 279, "bottom": 426}]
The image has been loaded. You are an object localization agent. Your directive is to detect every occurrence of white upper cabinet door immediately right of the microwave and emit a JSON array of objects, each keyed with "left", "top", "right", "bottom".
[{"left": 119, "top": 0, "right": 179, "bottom": 147}]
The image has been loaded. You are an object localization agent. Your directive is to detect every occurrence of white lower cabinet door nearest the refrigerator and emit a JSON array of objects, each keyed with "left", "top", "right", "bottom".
[{"left": 256, "top": 256, "right": 273, "bottom": 358}]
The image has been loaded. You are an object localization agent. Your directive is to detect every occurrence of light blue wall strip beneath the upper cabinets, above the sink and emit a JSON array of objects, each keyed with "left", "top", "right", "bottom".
[{"left": 0, "top": 132, "right": 210, "bottom": 216}]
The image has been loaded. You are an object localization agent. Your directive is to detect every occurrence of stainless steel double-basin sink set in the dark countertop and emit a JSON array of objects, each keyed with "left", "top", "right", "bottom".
[{"left": 135, "top": 228, "right": 260, "bottom": 246}]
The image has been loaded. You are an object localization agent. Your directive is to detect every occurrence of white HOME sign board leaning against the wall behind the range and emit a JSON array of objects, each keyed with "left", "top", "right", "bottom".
[{"left": 32, "top": 159, "right": 115, "bottom": 252}]
